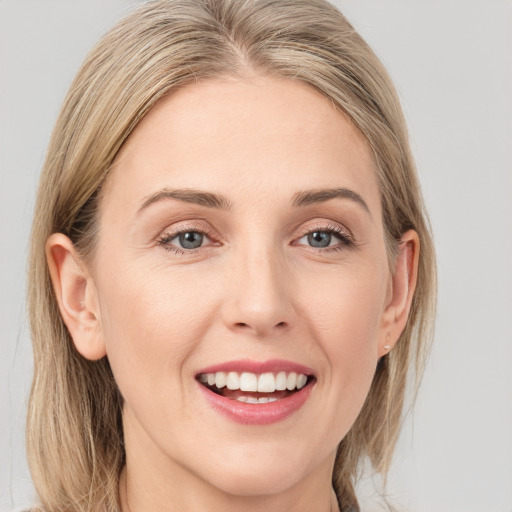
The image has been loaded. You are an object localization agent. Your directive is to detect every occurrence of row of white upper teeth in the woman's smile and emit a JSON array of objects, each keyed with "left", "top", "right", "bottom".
[{"left": 200, "top": 372, "right": 308, "bottom": 393}]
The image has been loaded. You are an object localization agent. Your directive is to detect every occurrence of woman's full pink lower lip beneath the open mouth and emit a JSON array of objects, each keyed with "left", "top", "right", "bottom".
[{"left": 197, "top": 382, "right": 314, "bottom": 425}]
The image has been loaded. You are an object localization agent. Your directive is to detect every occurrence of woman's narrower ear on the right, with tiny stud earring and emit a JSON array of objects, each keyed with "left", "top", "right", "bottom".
[{"left": 378, "top": 229, "right": 420, "bottom": 357}]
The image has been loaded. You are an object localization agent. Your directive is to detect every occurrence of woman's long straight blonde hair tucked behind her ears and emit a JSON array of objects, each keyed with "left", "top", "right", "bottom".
[{"left": 27, "top": 0, "right": 436, "bottom": 512}]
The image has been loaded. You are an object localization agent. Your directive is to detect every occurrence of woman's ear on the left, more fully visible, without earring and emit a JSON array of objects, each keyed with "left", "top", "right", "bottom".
[{"left": 46, "top": 233, "right": 106, "bottom": 360}]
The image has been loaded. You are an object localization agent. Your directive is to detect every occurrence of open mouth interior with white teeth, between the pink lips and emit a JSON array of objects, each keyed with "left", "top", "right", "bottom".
[{"left": 197, "top": 371, "right": 315, "bottom": 404}]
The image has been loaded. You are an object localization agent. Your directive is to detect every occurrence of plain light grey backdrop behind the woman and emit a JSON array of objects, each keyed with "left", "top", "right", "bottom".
[{"left": 0, "top": 0, "right": 512, "bottom": 512}]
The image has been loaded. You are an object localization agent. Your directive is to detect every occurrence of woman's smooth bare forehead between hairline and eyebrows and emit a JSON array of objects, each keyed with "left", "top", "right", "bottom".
[{"left": 103, "top": 76, "right": 380, "bottom": 216}]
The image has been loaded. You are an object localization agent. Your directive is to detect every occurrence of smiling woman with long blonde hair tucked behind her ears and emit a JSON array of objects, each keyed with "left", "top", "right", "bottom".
[{"left": 27, "top": 0, "right": 435, "bottom": 512}]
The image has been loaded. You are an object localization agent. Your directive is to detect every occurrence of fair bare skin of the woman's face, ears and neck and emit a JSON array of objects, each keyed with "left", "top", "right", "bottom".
[{"left": 47, "top": 77, "right": 419, "bottom": 512}]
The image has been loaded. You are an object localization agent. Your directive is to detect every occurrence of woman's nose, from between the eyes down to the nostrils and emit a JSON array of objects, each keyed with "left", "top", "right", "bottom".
[{"left": 222, "top": 245, "right": 296, "bottom": 338}]
